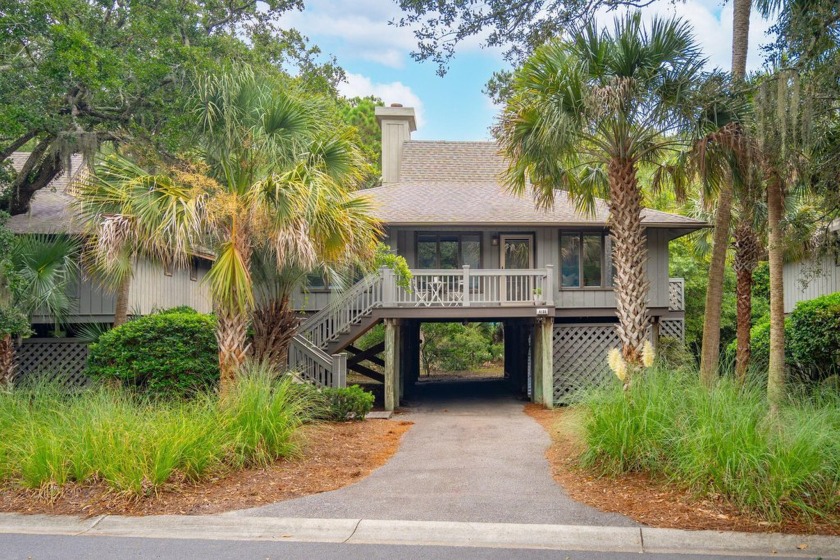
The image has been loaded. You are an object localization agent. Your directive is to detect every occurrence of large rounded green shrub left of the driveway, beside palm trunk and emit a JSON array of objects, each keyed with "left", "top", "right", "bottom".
[{"left": 87, "top": 307, "right": 219, "bottom": 397}]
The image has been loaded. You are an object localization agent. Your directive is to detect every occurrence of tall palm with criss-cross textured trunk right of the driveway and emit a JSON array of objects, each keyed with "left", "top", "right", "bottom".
[{"left": 497, "top": 14, "right": 704, "bottom": 378}]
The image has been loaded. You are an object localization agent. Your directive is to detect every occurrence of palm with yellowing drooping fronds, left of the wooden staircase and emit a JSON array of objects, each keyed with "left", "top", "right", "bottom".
[{"left": 194, "top": 68, "right": 378, "bottom": 391}]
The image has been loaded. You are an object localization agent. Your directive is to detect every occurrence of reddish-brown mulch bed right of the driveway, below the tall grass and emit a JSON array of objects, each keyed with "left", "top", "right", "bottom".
[{"left": 525, "top": 404, "right": 840, "bottom": 535}]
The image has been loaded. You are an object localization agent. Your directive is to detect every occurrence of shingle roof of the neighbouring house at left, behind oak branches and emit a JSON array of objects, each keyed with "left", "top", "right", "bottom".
[{"left": 6, "top": 152, "right": 83, "bottom": 233}]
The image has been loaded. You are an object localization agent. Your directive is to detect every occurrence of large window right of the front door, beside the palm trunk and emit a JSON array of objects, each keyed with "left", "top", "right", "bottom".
[{"left": 560, "top": 231, "right": 612, "bottom": 288}]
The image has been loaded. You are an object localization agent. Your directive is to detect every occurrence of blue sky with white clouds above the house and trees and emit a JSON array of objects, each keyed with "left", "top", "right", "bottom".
[{"left": 280, "top": 0, "right": 770, "bottom": 140}]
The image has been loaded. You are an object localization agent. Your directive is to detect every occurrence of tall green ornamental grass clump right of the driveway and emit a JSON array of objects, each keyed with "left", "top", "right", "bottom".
[{"left": 582, "top": 367, "right": 840, "bottom": 522}]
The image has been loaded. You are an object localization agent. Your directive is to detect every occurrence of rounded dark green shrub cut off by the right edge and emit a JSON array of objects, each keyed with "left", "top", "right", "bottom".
[{"left": 786, "top": 292, "right": 840, "bottom": 379}]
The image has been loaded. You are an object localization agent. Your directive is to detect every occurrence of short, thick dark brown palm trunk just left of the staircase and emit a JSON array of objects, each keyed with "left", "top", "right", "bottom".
[{"left": 252, "top": 296, "right": 300, "bottom": 369}]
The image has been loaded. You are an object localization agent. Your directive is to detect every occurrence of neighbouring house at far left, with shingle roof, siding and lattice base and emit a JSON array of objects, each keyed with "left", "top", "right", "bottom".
[{"left": 6, "top": 152, "right": 212, "bottom": 382}]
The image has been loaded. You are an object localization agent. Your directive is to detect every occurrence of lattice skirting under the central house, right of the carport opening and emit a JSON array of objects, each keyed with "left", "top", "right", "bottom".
[{"left": 554, "top": 319, "right": 685, "bottom": 405}]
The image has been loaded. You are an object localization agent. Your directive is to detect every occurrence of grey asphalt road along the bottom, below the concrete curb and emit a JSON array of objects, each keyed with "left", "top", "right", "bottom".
[{"left": 0, "top": 535, "right": 801, "bottom": 560}]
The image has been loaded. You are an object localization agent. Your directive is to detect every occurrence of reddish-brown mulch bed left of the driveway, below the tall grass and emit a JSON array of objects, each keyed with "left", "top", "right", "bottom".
[{"left": 0, "top": 420, "right": 412, "bottom": 516}]
